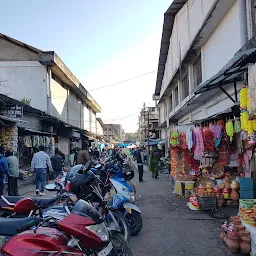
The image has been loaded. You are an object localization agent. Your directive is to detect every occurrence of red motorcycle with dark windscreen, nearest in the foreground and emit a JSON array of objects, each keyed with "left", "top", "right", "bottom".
[{"left": 1, "top": 200, "right": 133, "bottom": 256}]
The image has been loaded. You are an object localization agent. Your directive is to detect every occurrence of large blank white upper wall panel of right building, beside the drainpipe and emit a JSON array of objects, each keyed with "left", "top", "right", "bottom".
[{"left": 202, "top": 1, "right": 242, "bottom": 80}]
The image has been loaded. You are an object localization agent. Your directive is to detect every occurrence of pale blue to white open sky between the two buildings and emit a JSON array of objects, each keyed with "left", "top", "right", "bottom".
[{"left": 0, "top": 0, "right": 172, "bottom": 132}]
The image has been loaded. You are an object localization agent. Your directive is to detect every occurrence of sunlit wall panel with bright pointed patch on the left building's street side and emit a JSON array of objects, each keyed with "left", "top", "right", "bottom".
[{"left": 51, "top": 78, "right": 68, "bottom": 122}]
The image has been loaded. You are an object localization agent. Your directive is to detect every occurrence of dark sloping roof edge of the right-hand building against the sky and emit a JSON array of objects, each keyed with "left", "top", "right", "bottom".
[{"left": 155, "top": 0, "right": 187, "bottom": 95}]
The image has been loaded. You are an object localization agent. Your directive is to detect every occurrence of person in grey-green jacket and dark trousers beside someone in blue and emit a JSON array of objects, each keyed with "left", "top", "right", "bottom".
[{"left": 6, "top": 150, "right": 19, "bottom": 196}]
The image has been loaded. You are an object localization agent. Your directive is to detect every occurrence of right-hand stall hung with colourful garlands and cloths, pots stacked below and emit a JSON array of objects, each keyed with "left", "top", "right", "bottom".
[{"left": 170, "top": 103, "right": 244, "bottom": 210}]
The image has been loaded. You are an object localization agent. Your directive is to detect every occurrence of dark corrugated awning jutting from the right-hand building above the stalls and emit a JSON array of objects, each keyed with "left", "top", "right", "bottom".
[{"left": 194, "top": 48, "right": 256, "bottom": 94}]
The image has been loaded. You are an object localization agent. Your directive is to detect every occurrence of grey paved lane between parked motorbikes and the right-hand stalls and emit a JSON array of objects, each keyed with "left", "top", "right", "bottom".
[{"left": 131, "top": 166, "right": 233, "bottom": 256}]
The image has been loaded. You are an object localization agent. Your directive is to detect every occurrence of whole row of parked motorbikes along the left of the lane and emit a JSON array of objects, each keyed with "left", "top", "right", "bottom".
[{"left": 0, "top": 153, "right": 142, "bottom": 256}]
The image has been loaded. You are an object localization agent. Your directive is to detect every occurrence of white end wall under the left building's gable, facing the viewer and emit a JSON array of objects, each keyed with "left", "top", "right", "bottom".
[{"left": 0, "top": 61, "right": 47, "bottom": 112}]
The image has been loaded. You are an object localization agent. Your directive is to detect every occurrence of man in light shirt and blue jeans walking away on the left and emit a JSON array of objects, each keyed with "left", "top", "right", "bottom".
[{"left": 31, "top": 147, "right": 53, "bottom": 196}]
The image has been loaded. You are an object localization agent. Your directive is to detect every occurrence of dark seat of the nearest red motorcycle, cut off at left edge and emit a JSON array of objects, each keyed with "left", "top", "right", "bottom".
[{"left": 0, "top": 217, "right": 34, "bottom": 236}]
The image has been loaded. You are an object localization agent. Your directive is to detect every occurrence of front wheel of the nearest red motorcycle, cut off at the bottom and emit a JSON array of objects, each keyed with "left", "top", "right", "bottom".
[{"left": 109, "top": 231, "right": 133, "bottom": 256}]
